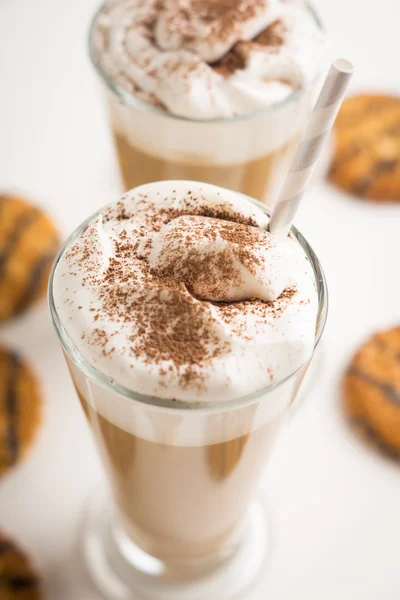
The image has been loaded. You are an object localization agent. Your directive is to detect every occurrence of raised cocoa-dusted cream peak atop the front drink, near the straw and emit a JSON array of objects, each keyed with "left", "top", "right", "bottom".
[{"left": 149, "top": 215, "right": 291, "bottom": 302}]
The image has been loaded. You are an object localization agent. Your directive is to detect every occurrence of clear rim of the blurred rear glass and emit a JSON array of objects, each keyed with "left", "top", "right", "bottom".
[{"left": 88, "top": 0, "right": 324, "bottom": 125}]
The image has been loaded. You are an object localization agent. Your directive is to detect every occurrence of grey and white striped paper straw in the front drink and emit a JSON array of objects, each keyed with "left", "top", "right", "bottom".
[{"left": 268, "top": 58, "right": 353, "bottom": 236}]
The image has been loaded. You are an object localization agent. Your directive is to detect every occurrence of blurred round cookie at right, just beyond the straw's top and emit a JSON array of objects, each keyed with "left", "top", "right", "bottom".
[{"left": 329, "top": 95, "right": 400, "bottom": 201}]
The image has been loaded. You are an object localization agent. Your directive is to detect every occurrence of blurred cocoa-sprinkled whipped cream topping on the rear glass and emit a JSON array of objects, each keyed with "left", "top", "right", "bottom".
[{"left": 92, "top": 0, "right": 323, "bottom": 119}]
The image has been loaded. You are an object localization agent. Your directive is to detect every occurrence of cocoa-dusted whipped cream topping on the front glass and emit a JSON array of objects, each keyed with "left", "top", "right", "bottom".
[{"left": 53, "top": 181, "right": 318, "bottom": 402}]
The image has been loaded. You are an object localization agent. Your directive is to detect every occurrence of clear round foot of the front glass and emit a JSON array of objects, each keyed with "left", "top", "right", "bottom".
[{"left": 82, "top": 494, "right": 270, "bottom": 600}]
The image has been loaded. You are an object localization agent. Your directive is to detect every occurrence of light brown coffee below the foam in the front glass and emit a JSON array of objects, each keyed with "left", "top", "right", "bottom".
[{"left": 81, "top": 397, "right": 280, "bottom": 566}]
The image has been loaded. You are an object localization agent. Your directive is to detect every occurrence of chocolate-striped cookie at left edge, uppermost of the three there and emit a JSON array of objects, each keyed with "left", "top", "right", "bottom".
[{"left": 0, "top": 194, "right": 59, "bottom": 322}]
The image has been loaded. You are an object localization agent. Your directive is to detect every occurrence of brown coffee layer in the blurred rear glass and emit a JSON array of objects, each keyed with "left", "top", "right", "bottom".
[{"left": 114, "top": 131, "right": 298, "bottom": 200}]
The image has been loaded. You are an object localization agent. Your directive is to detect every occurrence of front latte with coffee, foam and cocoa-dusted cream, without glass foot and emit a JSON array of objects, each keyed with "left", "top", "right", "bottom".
[{"left": 52, "top": 181, "right": 318, "bottom": 577}]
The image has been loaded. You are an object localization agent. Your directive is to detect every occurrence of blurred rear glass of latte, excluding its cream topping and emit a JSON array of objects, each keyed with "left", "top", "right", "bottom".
[{"left": 89, "top": 8, "right": 321, "bottom": 207}]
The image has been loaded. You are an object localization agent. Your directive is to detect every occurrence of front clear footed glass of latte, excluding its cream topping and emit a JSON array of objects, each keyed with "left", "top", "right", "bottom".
[{"left": 49, "top": 199, "right": 327, "bottom": 600}]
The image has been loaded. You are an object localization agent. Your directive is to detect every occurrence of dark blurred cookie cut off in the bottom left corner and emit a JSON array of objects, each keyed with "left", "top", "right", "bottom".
[{"left": 0, "top": 532, "right": 41, "bottom": 600}]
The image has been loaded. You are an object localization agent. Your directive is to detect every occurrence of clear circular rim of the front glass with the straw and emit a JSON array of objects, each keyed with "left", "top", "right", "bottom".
[{"left": 48, "top": 186, "right": 328, "bottom": 412}]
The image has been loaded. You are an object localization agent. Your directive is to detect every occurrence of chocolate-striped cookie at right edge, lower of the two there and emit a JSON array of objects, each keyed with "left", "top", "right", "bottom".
[{"left": 344, "top": 327, "right": 400, "bottom": 457}]
